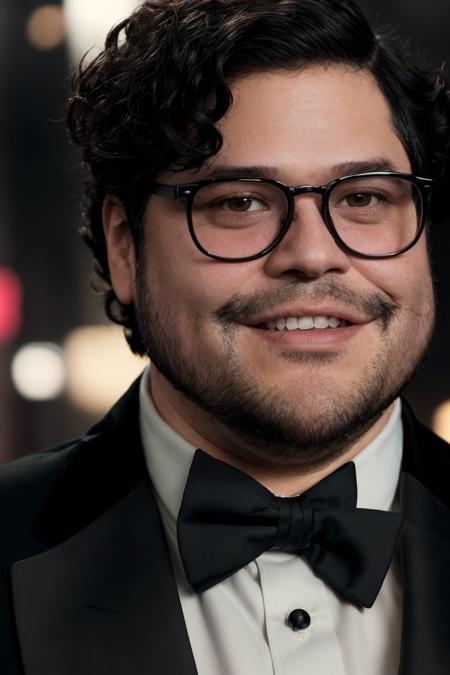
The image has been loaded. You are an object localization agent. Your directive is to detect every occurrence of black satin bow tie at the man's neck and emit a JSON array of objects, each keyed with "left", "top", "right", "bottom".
[{"left": 177, "top": 450, "right": 402, "bottom": 607}]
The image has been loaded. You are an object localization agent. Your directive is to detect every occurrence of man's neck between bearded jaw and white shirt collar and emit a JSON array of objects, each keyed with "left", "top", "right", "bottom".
[{"left": 149, "top": 367, "right": 394, "bottom": 496}]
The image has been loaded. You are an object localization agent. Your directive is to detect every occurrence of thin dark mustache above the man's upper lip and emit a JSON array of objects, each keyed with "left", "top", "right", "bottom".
[{"left": 216, "top": 278, "right": 398, "bottom": 327}]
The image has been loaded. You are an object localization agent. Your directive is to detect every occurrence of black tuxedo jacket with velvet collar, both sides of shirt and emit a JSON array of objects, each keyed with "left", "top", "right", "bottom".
[{"left": 0, "top": 383, "right": 450, "bottom": 675}]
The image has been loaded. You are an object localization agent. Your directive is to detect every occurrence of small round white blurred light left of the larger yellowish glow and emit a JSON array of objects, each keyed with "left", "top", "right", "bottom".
[{"left": 11, "top": 342, "right": 66, "bottom": 401}]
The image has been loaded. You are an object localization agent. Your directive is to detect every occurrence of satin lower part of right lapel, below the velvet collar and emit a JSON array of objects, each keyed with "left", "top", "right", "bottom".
[{"left": 399, "top": 473, "right": 450, "bottom": 675}]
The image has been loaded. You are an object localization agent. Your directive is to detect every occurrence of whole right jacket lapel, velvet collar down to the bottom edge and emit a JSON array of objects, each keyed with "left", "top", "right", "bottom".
[{"left": 399, "top": 408, "right": 450, "bottom": 675}]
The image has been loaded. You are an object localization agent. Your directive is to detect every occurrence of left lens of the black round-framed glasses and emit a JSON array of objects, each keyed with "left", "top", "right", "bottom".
[{"left": 192, "top": 180, "right": 288, "bottom": 259}]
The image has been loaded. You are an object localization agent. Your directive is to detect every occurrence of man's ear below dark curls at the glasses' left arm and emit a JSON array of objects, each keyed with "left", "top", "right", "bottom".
[{"left": 102, "top": 195, "right": 135, "bottom": 305}]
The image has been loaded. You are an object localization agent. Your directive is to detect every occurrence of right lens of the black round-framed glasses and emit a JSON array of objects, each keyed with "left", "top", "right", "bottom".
[{"left": 328, "top": 176, "right": 423, "bottom": 255}]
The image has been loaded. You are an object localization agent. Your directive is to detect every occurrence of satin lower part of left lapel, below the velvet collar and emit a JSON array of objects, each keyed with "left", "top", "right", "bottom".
[{"left": 12, "top": 481, "right": 197, "bottom": 675}]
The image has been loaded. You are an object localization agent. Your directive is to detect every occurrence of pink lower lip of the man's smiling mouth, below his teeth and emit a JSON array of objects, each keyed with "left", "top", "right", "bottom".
[{"left": 251, "top": 324, "right": 367, "bottom": 351}]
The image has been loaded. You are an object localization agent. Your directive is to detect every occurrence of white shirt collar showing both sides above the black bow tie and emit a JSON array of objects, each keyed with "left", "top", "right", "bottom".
[{"left": 139, "top": 368, "right": 403, "bottom": 535}]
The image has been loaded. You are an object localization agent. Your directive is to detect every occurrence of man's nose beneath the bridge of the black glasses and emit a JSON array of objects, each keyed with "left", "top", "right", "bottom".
[{"left": 265, "top": 194, "right": 351, "bottom": 279}]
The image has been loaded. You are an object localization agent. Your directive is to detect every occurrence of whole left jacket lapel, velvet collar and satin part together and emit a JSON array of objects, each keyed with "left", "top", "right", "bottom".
[{"left": 12, "top": 385, "right": 197, "bottom": 675}]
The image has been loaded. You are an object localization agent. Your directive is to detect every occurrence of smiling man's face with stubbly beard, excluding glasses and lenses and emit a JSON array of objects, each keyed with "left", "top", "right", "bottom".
[{"left": 122, "top": 66, "right": 434, "bottom": 464}]
